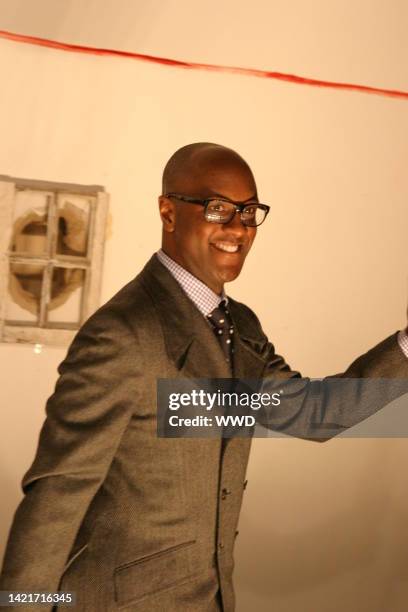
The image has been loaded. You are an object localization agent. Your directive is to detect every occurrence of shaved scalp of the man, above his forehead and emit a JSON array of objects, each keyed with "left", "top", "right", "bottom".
[{"left": 162, "top": 142, "right": 256, "bottom": 194}]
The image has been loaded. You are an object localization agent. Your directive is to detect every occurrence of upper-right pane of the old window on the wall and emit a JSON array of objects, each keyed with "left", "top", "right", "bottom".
[{"left": 57, "top": 193, "right": 95, "bottom": 257}]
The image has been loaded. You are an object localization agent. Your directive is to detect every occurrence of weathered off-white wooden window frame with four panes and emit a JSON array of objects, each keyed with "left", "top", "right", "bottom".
[{"left": 0, "top": 175, "right": 109, "bottom": 346}]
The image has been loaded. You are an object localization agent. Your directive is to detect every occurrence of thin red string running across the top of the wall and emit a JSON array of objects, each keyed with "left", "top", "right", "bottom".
[{"left": 0, "top": 30, "right": 408, "bottom": 100}]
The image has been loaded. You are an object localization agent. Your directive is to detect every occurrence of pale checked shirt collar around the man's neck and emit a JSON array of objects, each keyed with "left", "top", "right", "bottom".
[{"left": 156, "top": 249, "right": 228, "bottom": 317}]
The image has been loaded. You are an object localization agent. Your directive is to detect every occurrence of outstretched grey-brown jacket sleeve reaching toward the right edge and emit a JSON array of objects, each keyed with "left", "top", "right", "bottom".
[{"left": 244, "top": 308, "right": 408, "bottom": 441}]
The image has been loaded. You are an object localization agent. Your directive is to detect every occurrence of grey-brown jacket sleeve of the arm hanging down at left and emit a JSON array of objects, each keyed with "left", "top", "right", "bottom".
[{"left": 0, "top": 310, "right": 140, "bottom": 592}]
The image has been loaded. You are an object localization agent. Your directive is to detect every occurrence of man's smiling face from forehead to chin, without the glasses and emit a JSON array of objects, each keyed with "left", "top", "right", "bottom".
[{"left": 159, "top": 160, "right": 257, "bottom": 293}]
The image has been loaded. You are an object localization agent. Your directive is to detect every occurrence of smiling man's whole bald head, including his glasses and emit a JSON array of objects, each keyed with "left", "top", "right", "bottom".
[{"left": 159, "top": 144, "right": 260, "bottom": 294}]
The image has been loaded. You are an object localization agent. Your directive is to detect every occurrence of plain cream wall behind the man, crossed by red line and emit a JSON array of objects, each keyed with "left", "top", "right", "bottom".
[{"left": 0, "top": 0, "right": 408, "bottom": 612}]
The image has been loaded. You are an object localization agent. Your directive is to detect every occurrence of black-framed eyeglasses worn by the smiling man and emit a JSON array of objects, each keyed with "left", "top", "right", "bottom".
[{"left": 164, "top": 193, "right": 270, "bottom": 227}]
